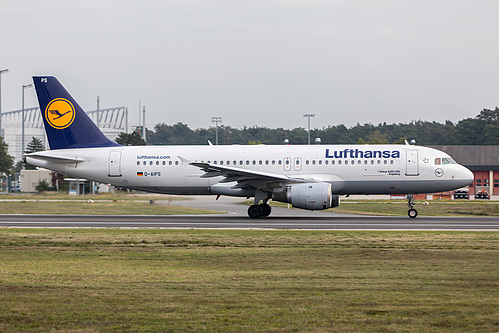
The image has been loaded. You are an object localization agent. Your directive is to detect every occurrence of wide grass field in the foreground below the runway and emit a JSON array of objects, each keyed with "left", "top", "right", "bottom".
[{"left": 0, "top": 229, "right": 499, "bottom": 332}]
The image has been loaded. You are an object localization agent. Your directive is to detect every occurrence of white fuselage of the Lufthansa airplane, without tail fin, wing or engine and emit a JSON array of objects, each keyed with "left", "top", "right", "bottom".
[{"left": 26, "top": 145, "right": 473, "bottom": 196}]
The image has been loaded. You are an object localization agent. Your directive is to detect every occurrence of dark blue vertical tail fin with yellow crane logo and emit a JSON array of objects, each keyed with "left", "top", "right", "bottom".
[{"left": 33, "top": 76, "right": 119, "bottom": 149}]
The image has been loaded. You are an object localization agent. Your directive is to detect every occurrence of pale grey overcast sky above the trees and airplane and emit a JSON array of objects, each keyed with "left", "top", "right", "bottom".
[{"left": 0, "top": 0, "right": 499, "bottom": 128}]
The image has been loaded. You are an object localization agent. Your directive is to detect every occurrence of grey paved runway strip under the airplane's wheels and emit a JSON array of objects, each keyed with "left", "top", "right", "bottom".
[{"left": 0, "top": 214, "right": 499, "bottom": 231}]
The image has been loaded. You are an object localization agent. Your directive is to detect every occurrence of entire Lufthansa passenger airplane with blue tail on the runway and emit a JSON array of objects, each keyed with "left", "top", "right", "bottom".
[{"left": 24, "top": 76, "right": 473, "bottom": 219}]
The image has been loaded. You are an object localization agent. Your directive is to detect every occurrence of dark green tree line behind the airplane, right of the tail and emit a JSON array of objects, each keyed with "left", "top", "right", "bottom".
[{"left": 116, "top": 107, "right": 499, "bottom": 145}]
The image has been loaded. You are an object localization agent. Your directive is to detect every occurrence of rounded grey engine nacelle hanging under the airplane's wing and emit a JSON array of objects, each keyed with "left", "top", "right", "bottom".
[{"left": 272, "top": 183, "right": 340, "bottom": 210}]
